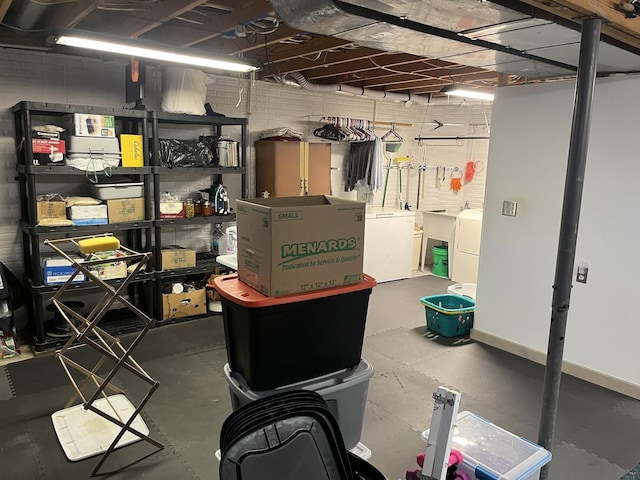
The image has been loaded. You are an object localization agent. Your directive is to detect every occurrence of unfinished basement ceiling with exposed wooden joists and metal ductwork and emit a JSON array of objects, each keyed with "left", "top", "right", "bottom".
[{"left": 0, "top": 0, "right": 640, "bottom": 95}]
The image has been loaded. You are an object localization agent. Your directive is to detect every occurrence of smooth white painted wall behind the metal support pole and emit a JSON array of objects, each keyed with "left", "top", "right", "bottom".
[{"left": 474, "top": 76, "right": 640, "bottom": 386}]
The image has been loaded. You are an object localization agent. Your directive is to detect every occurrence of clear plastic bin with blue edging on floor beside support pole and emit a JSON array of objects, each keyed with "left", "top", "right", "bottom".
[{"left": 422, "top": 412, "right": 551, "bottom": 480}]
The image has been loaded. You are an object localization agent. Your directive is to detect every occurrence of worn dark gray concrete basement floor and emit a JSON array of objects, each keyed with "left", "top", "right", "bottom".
[{"left": 0, "top": 276, "right": 640, "bottom": 480}]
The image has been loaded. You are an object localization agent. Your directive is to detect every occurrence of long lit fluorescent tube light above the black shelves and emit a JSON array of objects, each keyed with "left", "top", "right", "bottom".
[{"left": 54, "top": 31, "right": 259, "bottom": 72}]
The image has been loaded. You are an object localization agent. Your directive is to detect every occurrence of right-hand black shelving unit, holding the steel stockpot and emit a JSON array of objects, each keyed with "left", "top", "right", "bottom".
[{"left": 150, "top": 112, "right": 248, "bottom": 326}]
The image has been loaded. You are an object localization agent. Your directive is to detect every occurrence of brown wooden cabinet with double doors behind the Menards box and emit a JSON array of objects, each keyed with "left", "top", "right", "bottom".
[{"left": 256, "top": 140, "right": 331, "bottom": 197}]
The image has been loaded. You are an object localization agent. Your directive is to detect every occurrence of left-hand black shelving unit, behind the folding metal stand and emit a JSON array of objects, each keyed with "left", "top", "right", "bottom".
[{"left": 12, "top": 101, "right": 155, "bottom": 351}]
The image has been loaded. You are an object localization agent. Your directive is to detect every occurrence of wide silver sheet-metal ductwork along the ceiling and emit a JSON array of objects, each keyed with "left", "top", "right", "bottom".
[{"left": 270, "top": 0, "right": 640, "bottom": 79}]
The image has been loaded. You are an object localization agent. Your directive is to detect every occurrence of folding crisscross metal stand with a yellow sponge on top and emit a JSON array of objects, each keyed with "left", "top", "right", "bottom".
[{"left": 44, "top": 234, "right": 164, "bottom": 476}]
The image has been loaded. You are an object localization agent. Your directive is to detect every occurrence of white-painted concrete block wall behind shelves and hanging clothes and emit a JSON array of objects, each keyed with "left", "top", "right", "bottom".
[{"left": 0, "top": 49, "right": 491, "bottom": 273}]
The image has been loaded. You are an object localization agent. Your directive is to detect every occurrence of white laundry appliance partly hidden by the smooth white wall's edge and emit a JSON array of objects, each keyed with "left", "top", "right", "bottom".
[{"left": 451, "top": 209, "right": 482, "bottom": 283}]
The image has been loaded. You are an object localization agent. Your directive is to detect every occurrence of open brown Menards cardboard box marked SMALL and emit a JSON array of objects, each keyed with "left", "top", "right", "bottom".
[{"left": 236, "top": 195, "right": 365, "bottom": 297}]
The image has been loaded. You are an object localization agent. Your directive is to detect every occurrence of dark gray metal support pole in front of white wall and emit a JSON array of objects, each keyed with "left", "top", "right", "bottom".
[{"left": 538, "top": 18, "right": 602, "bottom": 480}]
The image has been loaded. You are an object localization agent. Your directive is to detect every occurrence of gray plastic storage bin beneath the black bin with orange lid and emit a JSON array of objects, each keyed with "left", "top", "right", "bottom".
[{"left": 224, "top": 359, "right": 373, "bottom": 450}]
